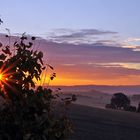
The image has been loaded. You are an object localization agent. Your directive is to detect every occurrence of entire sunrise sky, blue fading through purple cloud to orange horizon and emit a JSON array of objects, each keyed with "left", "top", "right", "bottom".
[{"left": 0, "top": 0, "right": 140, "bottom": 85}]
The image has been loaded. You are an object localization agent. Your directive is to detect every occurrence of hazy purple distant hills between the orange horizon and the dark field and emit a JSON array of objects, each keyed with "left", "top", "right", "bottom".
[{"left": 51, "top": 85, "right": 140, "bottom": 108}]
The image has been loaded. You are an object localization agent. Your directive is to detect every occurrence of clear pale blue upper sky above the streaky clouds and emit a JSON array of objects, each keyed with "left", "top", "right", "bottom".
[{"left": 0, "top": 0, "right": 140, "bottom": 37}]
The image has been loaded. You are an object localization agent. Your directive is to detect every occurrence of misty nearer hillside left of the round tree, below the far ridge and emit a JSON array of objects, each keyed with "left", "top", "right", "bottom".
[{"left": 55, "top": 88, "right": 112, "bottom": 108}]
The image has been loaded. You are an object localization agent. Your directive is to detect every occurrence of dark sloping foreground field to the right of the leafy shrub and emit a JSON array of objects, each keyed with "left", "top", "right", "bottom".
[{"left": 70, "top": 105, "right": 140, "bottom": 140}]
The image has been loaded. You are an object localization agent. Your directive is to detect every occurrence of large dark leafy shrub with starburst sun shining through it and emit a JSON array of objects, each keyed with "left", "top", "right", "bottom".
[{"left": 0, "top": 34, "right": 75, "bottom": 140}]
